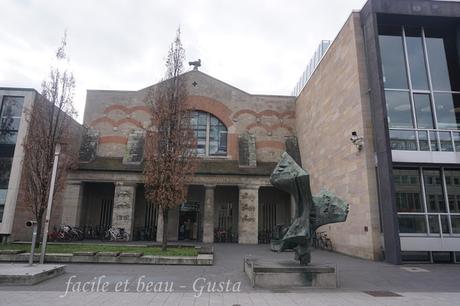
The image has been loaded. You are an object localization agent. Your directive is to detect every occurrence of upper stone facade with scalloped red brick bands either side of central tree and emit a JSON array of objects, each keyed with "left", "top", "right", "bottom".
[{"left": 84, "top": 71, "right": 295, "bottom": 161}]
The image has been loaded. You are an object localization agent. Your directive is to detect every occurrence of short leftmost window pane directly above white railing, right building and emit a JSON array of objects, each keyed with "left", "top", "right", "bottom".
[{"left": 385, "top": 91, "right": 414, "bottom": 128}]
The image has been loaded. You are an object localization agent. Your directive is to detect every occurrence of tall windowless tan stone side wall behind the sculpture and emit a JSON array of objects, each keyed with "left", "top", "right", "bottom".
[{"left": 296, "top": 13, "right": 381, "bottom": 259}]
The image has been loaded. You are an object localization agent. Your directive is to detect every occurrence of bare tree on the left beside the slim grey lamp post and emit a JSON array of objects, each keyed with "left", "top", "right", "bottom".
[{"left": 23, "top": 34, "right": 76, "bottom": 244}]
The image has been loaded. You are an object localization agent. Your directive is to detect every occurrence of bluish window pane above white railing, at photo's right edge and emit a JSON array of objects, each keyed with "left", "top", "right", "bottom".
[{"left": 434, "top": 93, "right": 460, "bottom": 130}]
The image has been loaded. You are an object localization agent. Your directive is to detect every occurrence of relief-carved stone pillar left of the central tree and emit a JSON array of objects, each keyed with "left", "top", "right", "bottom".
[{"left": 112, "top": 182, "right": 136, "bottom": 240}]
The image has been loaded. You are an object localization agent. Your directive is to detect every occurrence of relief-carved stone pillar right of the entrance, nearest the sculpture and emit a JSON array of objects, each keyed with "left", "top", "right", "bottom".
[{"left": 238, "top": 185, "right": 259, "bottom": 244}]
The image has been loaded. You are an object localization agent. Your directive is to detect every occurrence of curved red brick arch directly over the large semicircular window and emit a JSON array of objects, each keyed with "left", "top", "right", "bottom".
[{"left": 187, "top": 96, "right": 233, "bottom": 129}]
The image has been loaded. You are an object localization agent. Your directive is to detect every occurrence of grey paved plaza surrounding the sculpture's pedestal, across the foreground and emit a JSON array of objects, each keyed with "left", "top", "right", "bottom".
[{"left": 0, "top": 244, "right": 460, "bottom": 305}]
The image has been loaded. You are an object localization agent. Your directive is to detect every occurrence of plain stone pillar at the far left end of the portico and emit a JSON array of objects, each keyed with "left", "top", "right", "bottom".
[{"left": 61, "top": 181, "right": 83, "bottom": 226}]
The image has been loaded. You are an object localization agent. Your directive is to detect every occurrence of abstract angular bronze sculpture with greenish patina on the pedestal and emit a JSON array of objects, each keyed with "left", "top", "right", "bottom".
[{"left": 270, "top": 152, "right": 349, "bottom": 265}]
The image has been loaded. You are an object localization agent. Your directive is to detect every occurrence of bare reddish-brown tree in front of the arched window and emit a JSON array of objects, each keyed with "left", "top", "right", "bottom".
[{"left": 144, "top": 30, "right": 196, "bottom": 251}]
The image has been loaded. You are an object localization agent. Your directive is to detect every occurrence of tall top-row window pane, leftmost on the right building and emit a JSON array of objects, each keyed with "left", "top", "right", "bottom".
[{"left": 379, "top": 28, "right": 408, "bottom": 88}]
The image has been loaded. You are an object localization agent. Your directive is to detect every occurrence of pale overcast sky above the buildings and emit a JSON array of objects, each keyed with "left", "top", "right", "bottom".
[{"left": 0, "top": 0, "right": 365, "bottom": 122}]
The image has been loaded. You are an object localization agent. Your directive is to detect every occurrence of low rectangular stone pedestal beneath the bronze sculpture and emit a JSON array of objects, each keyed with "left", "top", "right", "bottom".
[{"left": 244, "top": 257, "right": 337, "bottom": 289}]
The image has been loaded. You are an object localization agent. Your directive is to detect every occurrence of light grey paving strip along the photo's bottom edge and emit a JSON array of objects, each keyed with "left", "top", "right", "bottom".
[{"left": 0, "top": 291, "right": 460, "bottom": 306}]
